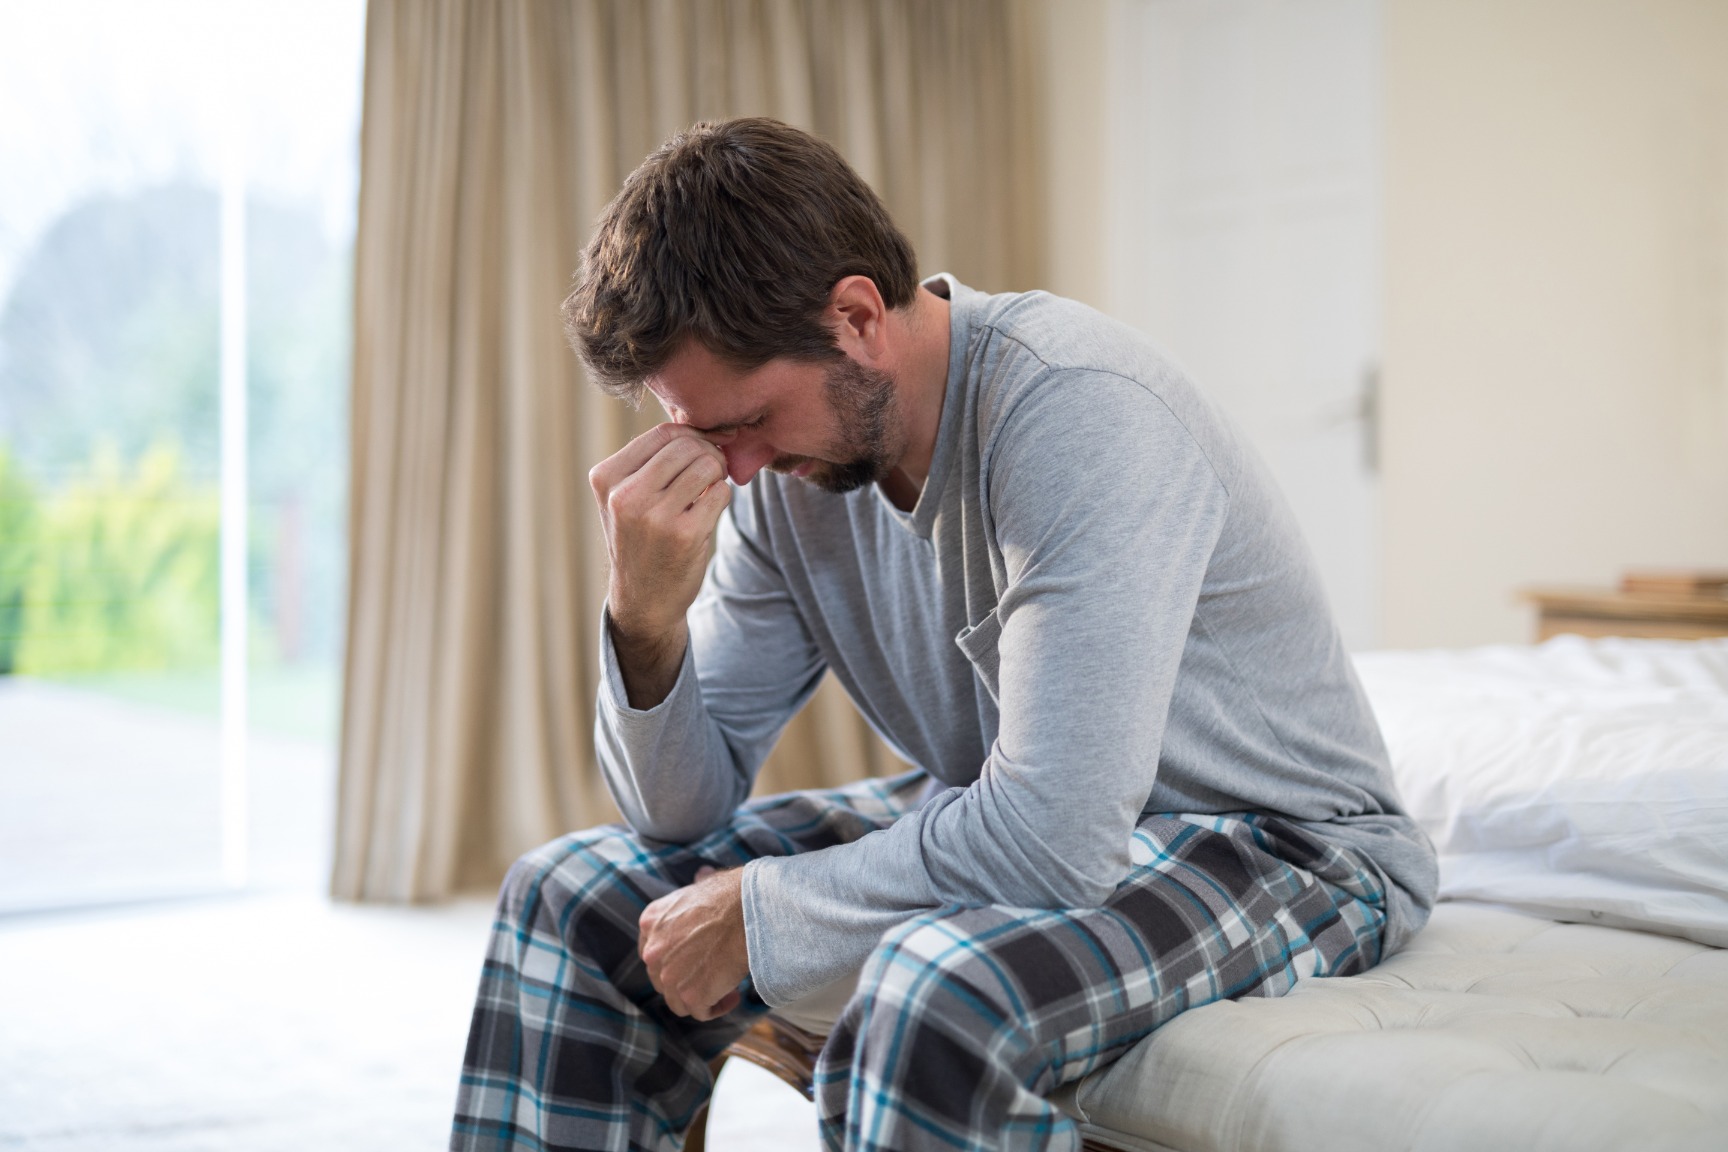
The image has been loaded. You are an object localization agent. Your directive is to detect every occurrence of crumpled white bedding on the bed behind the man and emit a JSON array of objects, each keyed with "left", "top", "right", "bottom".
[{"left": 1356, "top": 636, "right": 1728, "bottom": 946}]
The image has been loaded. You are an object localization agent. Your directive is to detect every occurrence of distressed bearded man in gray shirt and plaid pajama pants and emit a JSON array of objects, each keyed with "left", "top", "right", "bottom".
[{"left": 453, "top": 119, "right": 1436, "bottom": 1150}]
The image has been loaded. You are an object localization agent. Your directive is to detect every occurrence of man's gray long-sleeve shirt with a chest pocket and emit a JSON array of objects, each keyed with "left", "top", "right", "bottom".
[{"left": 596, "top": 278, "right": 1436, "bottom": 1003}]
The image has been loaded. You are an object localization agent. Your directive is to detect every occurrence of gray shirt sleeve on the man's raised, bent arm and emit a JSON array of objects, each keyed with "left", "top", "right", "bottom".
[{"left": 594, "top": 489, "right": 826, "bottom": 843}]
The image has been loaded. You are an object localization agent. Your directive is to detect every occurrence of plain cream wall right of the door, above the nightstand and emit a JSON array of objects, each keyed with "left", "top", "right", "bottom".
[{"left": 1382, "top": 0, "right": 1728, "bottom": 646}]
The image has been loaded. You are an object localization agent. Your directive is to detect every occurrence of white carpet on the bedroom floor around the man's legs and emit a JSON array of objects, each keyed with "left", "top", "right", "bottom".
[{"left": 0, "top": 896, "right": 816, "bottom": 1152}]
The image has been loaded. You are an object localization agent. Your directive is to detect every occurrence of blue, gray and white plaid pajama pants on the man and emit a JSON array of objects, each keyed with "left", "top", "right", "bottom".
[{"left": 451, "top": 772, "right": 1386, "bottom": 1152}]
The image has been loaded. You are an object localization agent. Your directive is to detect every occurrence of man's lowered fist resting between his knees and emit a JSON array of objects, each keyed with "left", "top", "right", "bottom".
[{"left": 638, "top": 867, "right": 750, "bottom": 1021}]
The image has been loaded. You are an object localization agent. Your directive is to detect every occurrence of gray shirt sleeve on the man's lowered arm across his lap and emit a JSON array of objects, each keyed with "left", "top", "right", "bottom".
[{"left": 743, "top": 371, "right": 1230, "bottom": 1003}]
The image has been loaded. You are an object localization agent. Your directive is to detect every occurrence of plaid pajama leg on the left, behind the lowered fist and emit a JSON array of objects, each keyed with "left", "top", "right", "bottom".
[{"left": 451, "top": 772, "right": 928, "bottom": 1152}]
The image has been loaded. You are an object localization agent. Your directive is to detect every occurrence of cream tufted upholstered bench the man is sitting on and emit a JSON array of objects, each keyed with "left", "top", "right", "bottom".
[{"left": 1059, "top": 903, "right": 1728, "bottom": 1152}]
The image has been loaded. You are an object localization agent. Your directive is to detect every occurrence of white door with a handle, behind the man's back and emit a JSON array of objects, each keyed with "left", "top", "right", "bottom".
[{"left": 1106, "top": 0, "right": 1381, "bottom": 649}]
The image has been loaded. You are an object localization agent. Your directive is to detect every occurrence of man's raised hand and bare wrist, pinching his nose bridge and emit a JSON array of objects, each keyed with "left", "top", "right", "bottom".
[{"left": 588, "top": 423, "right": 731, "bottom": 708}]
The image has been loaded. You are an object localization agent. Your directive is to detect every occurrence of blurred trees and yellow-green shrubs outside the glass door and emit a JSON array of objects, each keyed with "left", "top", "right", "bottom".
[{"left": 0, "top": 183, "right": 351, "bottom": 683}]
